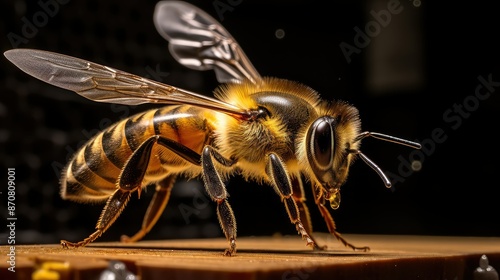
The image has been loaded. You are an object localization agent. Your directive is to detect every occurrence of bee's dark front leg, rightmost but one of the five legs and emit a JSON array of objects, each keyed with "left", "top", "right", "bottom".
[{"left": 266, "top": 153, "right": 319, "bottom": 248}]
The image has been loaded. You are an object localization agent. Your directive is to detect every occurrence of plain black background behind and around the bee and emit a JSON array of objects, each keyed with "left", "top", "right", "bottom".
[{"left": 0, "top": 0, "right": 500, "bottom": 245}]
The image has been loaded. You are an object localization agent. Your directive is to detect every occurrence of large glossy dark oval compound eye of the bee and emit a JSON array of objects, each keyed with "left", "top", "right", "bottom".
[{"left": 307, "top": 117, "right": 335, "bottom": 170}]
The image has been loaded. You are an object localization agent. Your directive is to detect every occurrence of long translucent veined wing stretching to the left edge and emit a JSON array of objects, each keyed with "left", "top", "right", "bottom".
[{"left": 4, "top": 49, "right": 246, "bottom": 116}]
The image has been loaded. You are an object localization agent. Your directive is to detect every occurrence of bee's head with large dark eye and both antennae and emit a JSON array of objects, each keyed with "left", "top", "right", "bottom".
[{"left": 304, "top": 103, "right": 420, "bottom": 209}]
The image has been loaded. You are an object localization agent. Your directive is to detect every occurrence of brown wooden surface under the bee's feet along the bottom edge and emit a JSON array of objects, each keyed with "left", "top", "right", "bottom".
[{"left": 0, "top": 234, "right": 500, "bottom": 280}]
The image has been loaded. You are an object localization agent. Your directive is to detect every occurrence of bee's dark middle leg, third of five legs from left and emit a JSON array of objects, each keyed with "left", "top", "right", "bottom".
[{"left": 201, "top": 146, "right": 236, "bottom": 256}]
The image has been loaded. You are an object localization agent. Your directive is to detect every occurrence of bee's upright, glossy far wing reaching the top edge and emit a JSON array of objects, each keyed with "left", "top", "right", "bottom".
[{"left": 154, "top": 1, "right": 262, "bottom": 83}]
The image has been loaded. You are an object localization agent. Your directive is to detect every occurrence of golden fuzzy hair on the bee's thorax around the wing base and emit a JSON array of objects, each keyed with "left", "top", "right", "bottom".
[{"left": 214, "top": 78, "right": 318, "bottom": 181}]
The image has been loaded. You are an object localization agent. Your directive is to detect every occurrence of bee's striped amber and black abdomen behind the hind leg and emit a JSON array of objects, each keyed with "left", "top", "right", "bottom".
[{"left": 61, "top": 106, "right": 214, "bottom": 202}]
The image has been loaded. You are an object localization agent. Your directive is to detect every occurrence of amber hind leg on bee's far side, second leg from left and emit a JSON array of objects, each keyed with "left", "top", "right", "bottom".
[{"left": 121, "top": 175, "right": 176, "bottom": 242}]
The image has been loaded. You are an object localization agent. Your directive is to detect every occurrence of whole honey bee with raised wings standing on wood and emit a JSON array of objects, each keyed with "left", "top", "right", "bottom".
[{"left": 5, "top": 1, "right": 420, "bottom": 256}]
